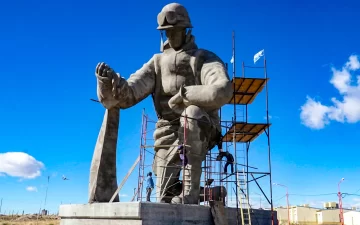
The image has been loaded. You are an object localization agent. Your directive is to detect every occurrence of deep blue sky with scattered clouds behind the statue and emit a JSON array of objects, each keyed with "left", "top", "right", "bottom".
[{"left": 0, "top": 0, "right": 360, "bottom": 213}]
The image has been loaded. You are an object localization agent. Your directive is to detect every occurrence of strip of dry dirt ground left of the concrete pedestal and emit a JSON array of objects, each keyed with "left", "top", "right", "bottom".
[{"left": 0, "top": 215, "right": 60, "bottom": 225}]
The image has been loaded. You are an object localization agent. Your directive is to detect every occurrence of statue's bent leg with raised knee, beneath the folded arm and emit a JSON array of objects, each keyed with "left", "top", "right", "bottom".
[{"left": 172, "top": 105, "right": 216, "bottom": 204}]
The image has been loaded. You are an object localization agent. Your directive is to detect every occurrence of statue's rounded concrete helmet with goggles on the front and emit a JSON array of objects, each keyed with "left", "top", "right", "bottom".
[{"left": 157, "top": 3, "right": 192, "bottom": 30}]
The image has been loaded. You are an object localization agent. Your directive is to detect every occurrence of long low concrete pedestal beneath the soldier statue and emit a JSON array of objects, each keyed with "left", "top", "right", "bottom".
[{"left": 59, "top": 202, "right": 276, "bottom": 225}]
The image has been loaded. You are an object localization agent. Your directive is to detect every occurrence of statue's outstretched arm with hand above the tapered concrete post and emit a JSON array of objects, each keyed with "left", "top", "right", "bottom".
[{"left": 96, "top": 56, "right": 155, "bottom": 109}]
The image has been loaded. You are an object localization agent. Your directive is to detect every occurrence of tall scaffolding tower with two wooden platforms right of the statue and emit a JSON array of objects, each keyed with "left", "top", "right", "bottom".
[{"left": 222, "top": 33, "right": 274, "bottom": 224}]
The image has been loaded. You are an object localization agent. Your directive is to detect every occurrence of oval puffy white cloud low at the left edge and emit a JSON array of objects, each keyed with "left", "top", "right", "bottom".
[{"left": 0, "top": 152, "right": 44, "bottom": 179}]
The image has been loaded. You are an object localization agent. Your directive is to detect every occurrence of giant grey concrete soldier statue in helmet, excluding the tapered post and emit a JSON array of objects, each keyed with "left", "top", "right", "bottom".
[{"left": 90, "top": 3, "right": 233, "bottom": 204}]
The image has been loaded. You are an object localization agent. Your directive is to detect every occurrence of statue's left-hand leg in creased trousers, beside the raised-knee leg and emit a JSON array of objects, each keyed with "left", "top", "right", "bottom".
[{"left": 153, "top": 121, "right": 181, "bottom": 202}]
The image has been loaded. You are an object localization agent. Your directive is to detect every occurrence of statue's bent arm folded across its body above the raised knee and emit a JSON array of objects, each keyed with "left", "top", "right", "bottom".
[{"left": 184, "top": 51, "right": 233, "bottom": 110}]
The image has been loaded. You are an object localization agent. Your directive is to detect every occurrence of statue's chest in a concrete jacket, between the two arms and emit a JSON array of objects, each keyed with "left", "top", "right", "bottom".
[{"left": 160, "top": 52, "right": 195, "bottom": 95}]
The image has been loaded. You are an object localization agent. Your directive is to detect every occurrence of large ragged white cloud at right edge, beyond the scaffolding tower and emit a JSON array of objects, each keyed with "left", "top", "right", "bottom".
[{"left": 300, "top": 55, "right": 360, "bottom": 129}]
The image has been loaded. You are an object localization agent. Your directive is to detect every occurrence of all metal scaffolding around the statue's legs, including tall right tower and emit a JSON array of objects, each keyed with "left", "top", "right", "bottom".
[{"left": 133, "top": 32, "right": 275, "bottom": 224}]
